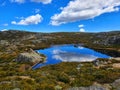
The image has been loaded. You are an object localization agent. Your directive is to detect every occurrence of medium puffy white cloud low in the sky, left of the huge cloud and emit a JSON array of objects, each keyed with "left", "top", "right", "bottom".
[{"left": 11, "top": 14, "right": 43, "bottom": 25}]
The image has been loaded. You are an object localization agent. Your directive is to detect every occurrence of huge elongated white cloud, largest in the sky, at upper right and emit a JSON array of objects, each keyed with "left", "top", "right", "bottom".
[{"left": 50, "top": 0, "right": 120, "bottom": 25}]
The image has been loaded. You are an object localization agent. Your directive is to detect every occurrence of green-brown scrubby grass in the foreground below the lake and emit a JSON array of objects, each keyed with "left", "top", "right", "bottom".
[{"left": 0, "top": 59, "right": 120, "bottom": 90}]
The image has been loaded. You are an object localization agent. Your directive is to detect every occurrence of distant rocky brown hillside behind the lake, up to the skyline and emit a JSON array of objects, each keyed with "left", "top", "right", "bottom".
[{"left": 0, "top": 30, "right": 120, "bottom": 56}]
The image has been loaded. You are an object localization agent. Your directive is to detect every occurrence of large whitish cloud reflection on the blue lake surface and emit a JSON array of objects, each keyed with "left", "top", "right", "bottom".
[{"left": 52, "top": 48, "right": 97, "bottom": 62}]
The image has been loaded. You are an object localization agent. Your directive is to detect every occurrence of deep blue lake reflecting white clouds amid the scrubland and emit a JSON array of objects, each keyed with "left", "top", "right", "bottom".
[{"left": 33, "top": 45, "right": 110, "bottom": 69}]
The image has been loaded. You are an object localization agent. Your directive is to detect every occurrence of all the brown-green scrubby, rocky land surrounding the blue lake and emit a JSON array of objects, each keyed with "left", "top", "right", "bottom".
[{"left": 0, "top": 30, "right": 120, "bottom": 90}]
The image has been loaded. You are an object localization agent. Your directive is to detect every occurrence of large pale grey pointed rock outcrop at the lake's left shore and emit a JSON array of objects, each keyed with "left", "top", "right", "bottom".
[{"left": 15, "top": 49, "right": 45, "bottom": 63}]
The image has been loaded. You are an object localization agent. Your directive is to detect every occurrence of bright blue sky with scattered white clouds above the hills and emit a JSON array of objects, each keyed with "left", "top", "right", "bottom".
[{"left": 0, "top": 0, "right": 120, "bottom": 32}]
